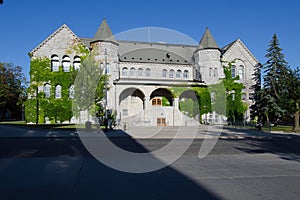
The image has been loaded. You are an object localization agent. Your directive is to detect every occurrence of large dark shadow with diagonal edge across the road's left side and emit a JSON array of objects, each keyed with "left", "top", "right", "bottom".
[{"left": 0, "top": 127, "right": 219, "bottom": 200}]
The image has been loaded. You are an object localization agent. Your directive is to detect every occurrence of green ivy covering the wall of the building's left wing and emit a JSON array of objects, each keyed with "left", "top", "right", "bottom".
[{"left": 25, "top": 58, "right": 77, "bottom": 123}]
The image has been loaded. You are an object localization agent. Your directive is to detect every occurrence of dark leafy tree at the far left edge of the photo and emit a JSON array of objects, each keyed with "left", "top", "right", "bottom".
[{"left": 0, "top": 63, "right": 26, "bottom": 120}]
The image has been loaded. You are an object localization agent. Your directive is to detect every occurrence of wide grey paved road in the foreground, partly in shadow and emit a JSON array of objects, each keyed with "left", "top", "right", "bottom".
[{"left": 0, "top": 126, "right": 300, "bottom": 200}]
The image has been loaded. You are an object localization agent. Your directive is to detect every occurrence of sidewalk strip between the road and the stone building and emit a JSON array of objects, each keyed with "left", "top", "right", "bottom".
[{"left": 0, "top": 125, "right": 300, "bottom": 139}]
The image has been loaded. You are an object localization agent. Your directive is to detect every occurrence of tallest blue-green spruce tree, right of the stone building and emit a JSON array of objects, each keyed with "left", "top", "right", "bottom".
[{"left": 263, "top": 34, "right": 288, "bottom": 123}]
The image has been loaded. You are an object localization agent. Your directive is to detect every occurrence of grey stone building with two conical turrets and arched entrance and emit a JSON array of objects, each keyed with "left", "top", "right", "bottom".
[{"left": 30, "top": 19, "right": 258, "bottom": 126}]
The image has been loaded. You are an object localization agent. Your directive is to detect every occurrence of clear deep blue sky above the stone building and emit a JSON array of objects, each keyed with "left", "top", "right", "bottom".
[{"left": 0, "top": 0, "right": 300, "bottom": 78}]
